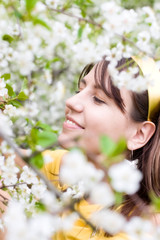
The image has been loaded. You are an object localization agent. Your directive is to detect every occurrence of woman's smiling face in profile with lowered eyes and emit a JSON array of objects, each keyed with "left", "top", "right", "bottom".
[{"left": 59, "top": 64, "right": 134, "bottom": 153}]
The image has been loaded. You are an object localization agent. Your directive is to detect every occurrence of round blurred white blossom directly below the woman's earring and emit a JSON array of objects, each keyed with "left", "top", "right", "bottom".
[{"left": 108, "top": 161, "right": 142, "bottom": 194}]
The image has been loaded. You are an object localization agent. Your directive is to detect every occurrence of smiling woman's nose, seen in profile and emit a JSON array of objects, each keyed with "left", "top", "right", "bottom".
[{"left": 66, "top": 93, "right": 84, "bottom": 113}]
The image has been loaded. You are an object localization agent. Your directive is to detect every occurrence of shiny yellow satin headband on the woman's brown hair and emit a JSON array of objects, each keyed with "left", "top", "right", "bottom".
[{"left": 132, "top": 56, "right": 160, "bottom": 121}]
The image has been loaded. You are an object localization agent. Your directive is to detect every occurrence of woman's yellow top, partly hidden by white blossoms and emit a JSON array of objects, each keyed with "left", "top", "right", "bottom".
[{"left": 42, "top": 150, "right": 128, "bottom": 240}]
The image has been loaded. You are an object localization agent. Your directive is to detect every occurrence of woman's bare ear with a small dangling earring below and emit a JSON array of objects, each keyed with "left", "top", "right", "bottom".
[{"left": 127, "top": 121, "right": 156, "bottom": 150}]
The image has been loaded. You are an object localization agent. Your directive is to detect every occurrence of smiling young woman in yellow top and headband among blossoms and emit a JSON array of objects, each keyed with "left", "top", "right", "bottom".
[{"left": 43, "top": 58, "right": 160, "bottom": 240}]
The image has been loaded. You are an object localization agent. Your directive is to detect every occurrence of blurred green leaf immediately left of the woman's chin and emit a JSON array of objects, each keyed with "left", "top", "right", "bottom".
[{"left": 36, "top": 131, "right": 57, "bottom": 148}]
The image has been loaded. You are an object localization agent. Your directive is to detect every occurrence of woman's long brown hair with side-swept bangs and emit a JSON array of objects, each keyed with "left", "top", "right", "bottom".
[{"left": 80, "top": 58, "right": 160, "bottom": 217}]
